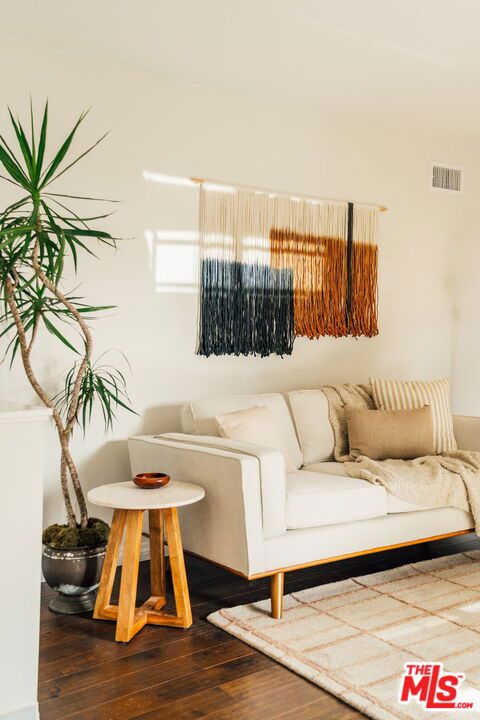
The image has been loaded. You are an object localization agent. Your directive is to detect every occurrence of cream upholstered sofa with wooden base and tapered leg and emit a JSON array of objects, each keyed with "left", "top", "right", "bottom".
[{"left": 129, "top": 390, "right": 480, "bottom": 617}]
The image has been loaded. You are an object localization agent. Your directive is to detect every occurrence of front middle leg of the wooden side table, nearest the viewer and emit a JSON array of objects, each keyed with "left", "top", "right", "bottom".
[{"left": 115, "top": 510, "right": 147, "bottom": 642}]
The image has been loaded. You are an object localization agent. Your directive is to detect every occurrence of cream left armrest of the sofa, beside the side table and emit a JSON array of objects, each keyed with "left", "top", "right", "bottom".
[{"left": 129, "top": 434, "right": 286, "bottom": 575}]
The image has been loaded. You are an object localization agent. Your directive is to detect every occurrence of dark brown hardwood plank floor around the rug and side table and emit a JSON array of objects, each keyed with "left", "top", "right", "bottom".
[{"left": 39, "top": 535, "right": 480, "bottom": 720}]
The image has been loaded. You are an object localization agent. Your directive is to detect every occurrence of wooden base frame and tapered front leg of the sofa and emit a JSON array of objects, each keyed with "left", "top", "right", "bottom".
[{"left": 185, "top": 528, "right": 474, "bottom": 620}]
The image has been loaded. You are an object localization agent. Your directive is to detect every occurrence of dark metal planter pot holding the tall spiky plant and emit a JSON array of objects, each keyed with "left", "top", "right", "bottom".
[{"left": 42, "top": 544, "right": 107, "bottom": 614}]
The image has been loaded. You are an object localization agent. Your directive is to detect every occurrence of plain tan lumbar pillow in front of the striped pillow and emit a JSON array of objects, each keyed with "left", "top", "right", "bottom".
[{"left": 346, "top": 406, "right": 435, "bottom": 460}]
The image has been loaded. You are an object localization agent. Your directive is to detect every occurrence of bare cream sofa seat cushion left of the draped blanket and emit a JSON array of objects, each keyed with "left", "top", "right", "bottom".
[{"left": 286, "top": 470, "right": 387, "bottom": 530}]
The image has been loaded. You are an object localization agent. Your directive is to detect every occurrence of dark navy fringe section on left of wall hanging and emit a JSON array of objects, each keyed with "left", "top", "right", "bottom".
[{"left": 197, "top": 259, "right": 295, "bottom": 357}]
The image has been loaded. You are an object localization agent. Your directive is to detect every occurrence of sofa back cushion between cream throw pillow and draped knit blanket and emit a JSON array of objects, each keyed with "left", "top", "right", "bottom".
[{"left": 287, "top": 390, "right": 335, "bottom": 465}]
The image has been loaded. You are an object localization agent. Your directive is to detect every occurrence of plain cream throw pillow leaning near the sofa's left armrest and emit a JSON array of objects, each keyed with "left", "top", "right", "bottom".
[{"left": 215, "top": 405, "right": 297, "bottom": 472}]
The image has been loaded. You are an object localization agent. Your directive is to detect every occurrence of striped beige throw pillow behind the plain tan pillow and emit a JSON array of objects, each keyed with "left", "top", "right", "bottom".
[{"left": 370, "top": 378, "right": 457, "bottom": 453}]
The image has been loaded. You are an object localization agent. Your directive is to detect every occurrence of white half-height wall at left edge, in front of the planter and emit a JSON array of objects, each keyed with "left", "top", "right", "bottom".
[{"left": 0, "top": 400, "right": 51, "bottom": 720}]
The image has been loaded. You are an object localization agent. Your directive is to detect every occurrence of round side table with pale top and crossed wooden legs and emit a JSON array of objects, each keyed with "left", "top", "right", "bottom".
[{"left": 88, "top": 480, "right": 205, "bottom": 642}]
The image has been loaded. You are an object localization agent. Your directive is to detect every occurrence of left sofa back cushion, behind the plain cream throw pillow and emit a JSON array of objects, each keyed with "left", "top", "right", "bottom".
[{"left": 182, "top": 393, "right": 303, "bottom": 468}]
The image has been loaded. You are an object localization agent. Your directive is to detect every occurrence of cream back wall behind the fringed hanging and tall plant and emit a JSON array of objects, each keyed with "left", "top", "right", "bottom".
[{"left": 0, "top": 33, "right": 473, "bottom": 523}]
